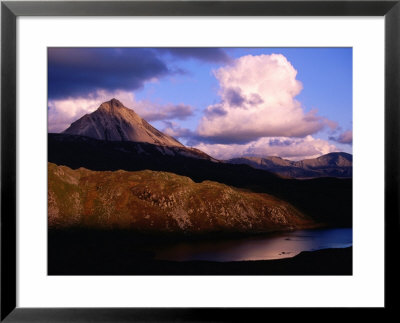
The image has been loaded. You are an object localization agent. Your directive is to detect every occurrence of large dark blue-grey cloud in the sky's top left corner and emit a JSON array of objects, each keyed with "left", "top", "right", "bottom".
[{"left": 48, "top": 48, "right": 171, "bottom": 99}]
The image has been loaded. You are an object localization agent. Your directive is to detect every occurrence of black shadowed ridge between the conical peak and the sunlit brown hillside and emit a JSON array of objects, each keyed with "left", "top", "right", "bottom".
[{"left": 48, "top": 134, "right": 352, "bottom": 226}]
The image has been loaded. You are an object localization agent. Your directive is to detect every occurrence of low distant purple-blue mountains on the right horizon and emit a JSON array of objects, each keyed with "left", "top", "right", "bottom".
[{"left": 228, "top": 152, "right": 353, "bottom": 178}]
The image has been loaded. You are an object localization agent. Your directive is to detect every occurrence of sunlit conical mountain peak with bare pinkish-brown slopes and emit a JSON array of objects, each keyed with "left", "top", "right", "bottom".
[{"left": 63, "top": 99, "right": 184, "bottom": 147}]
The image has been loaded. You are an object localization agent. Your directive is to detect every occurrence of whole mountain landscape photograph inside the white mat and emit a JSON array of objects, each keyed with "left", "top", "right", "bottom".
[{"left": 47, "top": 47, "right": 353, "bottom": 275}]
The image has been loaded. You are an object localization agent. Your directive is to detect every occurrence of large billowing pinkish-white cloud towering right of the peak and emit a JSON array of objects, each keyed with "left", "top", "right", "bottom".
[{"left": 197, "top": 54, "right": 337, "bottom": 144}]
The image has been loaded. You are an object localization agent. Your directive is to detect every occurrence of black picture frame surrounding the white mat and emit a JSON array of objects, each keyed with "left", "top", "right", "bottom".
[{"left": 0, "top": 0, "right": 400, "bottom": 322}]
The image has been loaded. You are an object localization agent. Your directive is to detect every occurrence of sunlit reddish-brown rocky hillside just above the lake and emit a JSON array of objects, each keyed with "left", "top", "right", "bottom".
[{"left": 48, "top": 163, "right": 316, "bottom": 233}]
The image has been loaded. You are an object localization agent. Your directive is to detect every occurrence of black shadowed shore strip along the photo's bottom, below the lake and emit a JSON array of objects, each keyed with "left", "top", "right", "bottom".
[{"left": 48, "top": 247, "right": 353, "bottom": 276}]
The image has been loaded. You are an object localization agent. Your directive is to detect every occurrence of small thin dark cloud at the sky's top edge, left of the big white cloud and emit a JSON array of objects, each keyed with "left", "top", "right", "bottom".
[{"left": 158, "top": 47, "right": 231, "bottom": 63}]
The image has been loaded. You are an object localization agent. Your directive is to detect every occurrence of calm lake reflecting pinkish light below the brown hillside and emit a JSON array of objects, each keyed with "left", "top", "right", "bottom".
[{"left": 153, "top": 228, "right": 353, "bottom": 261}]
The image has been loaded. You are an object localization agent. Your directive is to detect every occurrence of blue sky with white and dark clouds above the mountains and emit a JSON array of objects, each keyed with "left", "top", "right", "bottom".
[{"left": 48, "top": 47, "right": 353, "bottom": 160}]
